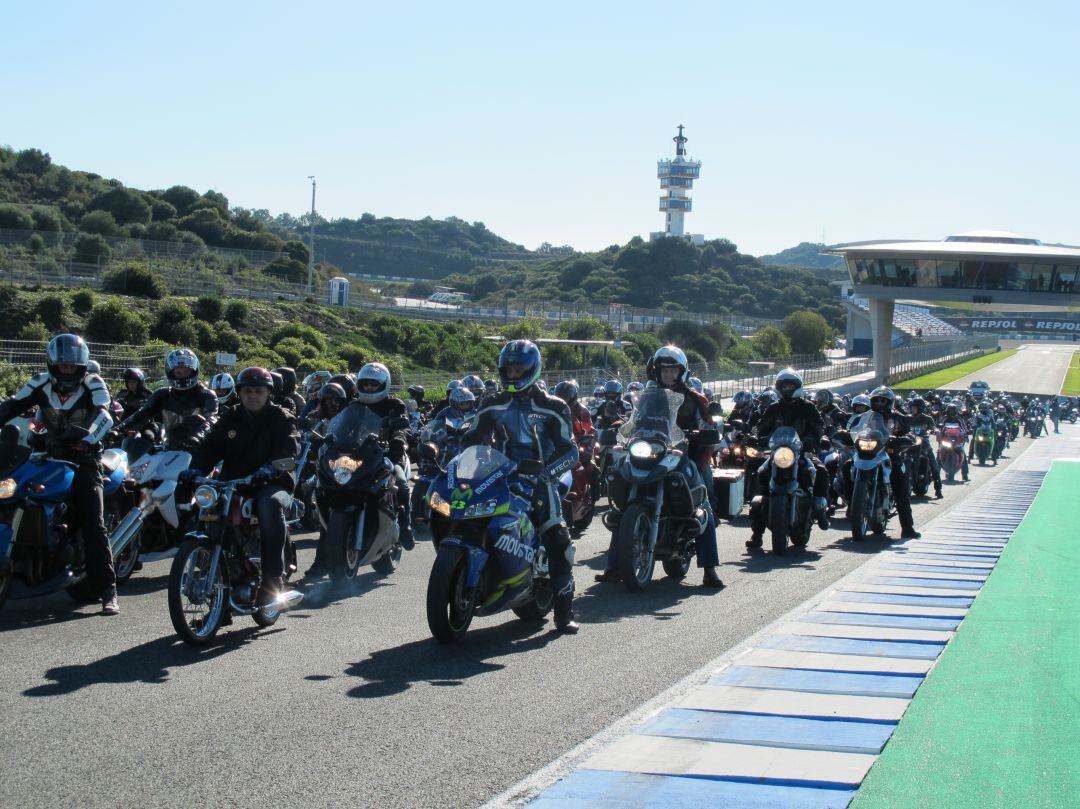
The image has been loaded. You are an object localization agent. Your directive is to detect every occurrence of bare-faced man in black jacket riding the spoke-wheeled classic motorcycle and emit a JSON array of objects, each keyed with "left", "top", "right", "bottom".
[{"left": 179, "top": 367, "right": 300, "bottom": 608}]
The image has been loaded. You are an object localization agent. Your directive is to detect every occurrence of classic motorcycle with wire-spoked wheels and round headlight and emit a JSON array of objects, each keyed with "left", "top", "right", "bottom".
[{"left": 168, "top": 466, "right": 303, "bottom": 646}]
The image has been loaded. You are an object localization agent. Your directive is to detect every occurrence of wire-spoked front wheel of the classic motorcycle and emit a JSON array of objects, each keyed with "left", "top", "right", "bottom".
[{"left": 168, "top": 541, "right": 229, "bottom": 646}]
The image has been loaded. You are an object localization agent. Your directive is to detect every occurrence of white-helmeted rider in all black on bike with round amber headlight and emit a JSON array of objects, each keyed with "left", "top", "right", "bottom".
[{"left": 746, "top": 368, "right": 828, "bottom": 548}]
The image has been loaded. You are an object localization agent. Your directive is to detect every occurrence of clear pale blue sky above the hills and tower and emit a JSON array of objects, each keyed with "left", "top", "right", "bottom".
[{"left": 0, "top": 0, "right": 1080, "bottom": 255}]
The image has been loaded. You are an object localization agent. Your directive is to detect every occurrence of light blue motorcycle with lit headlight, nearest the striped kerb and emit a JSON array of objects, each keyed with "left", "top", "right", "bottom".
[{"left": 848, "top": 412, "right": 913, "bottom": 540}]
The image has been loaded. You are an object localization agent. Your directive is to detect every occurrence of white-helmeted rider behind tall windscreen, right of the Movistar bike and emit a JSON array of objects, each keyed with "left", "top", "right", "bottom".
[{"left": 596, "top": 346, "right": 724, "bottom": 589}]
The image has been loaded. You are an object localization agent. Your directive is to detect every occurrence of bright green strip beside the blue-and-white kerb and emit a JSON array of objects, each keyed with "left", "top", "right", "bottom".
[{"left": 851, "top": 461, "right": 1080, "bottom": 809}]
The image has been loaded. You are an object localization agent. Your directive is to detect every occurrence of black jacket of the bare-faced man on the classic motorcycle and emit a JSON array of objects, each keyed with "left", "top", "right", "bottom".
[{"left": 191, "top": 403, "right": 300, "bottom": 490}]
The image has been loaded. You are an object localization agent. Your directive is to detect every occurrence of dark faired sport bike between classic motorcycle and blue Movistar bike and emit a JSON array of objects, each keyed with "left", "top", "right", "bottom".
[{"left": 315, "top": 404, "right": 407, "bottom": 581}]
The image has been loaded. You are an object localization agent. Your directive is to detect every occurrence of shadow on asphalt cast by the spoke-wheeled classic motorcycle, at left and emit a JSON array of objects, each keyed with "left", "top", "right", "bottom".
[{"left": 23, "top": 626, "right": 284, "bottom": 697}]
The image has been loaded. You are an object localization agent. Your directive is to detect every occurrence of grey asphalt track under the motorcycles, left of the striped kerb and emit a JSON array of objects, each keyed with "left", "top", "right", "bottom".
[{"left": 0, "top": 349, "right": 1067, "bottom": 808}]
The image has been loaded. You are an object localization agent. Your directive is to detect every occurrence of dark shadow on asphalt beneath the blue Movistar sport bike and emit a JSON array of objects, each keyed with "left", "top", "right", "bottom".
[{"left": 339, "top": 614, "right": 558, "bottom": 699}]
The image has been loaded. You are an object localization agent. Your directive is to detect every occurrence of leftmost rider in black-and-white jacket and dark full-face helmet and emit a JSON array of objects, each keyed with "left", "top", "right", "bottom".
[{"left": 0, "top": 334, "right": 120, "bottom": 616}]
